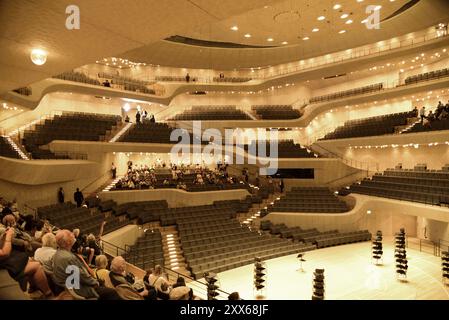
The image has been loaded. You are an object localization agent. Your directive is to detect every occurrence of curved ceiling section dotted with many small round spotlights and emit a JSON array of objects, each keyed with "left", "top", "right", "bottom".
[{"left": 120, "top": 0, "right": 449, "bottom": 70}]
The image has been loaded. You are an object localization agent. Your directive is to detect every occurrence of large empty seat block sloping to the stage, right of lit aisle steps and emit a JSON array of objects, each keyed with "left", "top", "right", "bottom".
[{"left": 175, "top": 203, "right": 313, "bottom": 278}]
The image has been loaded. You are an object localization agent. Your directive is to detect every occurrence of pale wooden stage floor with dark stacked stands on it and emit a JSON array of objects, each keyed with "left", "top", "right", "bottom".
[{"left": 201, "top": 238, "right": 449, "bottom": 300}]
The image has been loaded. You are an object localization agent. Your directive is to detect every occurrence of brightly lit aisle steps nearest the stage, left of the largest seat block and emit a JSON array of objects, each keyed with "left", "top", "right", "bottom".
[{"left": 159, "top": 226, "right": 190, "bottom": 277}]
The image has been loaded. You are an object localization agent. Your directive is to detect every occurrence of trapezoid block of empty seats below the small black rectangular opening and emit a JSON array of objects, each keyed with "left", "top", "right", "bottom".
[{"left": 268, "top": 187, "right": 349, "bottom": 213}]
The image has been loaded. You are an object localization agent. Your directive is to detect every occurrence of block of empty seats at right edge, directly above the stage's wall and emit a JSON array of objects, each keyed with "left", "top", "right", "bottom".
[{"left": 339, "top": 166, "right": 449, "bottom": 205}]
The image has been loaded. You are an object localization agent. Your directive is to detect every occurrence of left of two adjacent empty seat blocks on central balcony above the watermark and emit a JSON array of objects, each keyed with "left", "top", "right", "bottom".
[{"left": 170, "top": 106, "right": 251, "bottom": 121}]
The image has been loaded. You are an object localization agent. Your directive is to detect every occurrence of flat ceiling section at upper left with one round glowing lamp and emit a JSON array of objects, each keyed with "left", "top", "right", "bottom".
[{"left": 0, "top": 0, "right": 279, "bottom": 93}]
